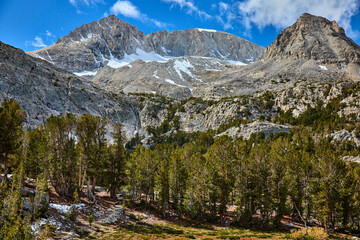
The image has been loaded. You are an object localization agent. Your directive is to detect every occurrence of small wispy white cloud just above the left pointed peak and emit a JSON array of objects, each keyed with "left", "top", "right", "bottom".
[{"left": 110, "top": 0, "right": 168, "bottom": 28}]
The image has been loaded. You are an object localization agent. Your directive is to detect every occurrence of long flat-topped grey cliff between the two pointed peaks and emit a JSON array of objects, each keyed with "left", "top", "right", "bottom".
[{"left": 145, "top": 28, "right": 264, "bottom": 63}]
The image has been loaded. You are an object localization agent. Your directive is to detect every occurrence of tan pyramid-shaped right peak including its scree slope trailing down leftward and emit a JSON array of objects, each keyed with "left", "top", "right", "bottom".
[{"left": 193, "top": 14, "right": 360, "bottom": 98}]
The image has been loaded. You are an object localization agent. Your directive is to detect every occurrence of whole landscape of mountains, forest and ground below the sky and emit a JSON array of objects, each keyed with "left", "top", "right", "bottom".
[{"left": 0, "top": 10, "right": 360, "bottom": 240}]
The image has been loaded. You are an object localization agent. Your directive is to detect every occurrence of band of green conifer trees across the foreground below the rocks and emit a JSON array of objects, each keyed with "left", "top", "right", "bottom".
[{"left": 0, "top": 97, "right": 360, "bottom": 234}]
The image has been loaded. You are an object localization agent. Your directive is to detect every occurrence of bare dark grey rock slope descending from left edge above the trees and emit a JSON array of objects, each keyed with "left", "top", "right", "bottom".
[{"left": 0, "top": 42, "right": 140, "bottom": 136}]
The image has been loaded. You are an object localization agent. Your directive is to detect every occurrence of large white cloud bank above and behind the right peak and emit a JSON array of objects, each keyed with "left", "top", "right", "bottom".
[{"left": 238, "top": 0, "right": 359, "bottom": 37}]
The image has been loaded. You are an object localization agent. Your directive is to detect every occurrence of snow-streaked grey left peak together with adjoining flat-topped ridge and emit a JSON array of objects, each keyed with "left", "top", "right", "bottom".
[{"left": 29, "top": 15, "right": 264, "bottom": 72}]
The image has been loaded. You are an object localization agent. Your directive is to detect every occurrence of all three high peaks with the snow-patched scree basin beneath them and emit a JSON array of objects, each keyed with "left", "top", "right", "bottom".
[{"left": 30, "top": 14, "right": 360, "bottom": 99}]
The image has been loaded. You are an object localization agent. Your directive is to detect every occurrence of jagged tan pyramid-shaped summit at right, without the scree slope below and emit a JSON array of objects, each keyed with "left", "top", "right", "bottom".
[{"left": 261, "top": 13, "right": 360, "bottom": 67}]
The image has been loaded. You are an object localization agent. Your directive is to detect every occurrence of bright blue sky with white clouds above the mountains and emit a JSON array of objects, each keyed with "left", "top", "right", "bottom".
[{"left": 0, "top": 0, "right": 360, "bottom": 51}]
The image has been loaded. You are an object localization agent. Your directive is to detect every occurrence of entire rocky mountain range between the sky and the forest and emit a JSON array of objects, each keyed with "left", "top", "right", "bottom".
[{"left": 0, "top": 14, "right": 360, "bottom": 141}]
